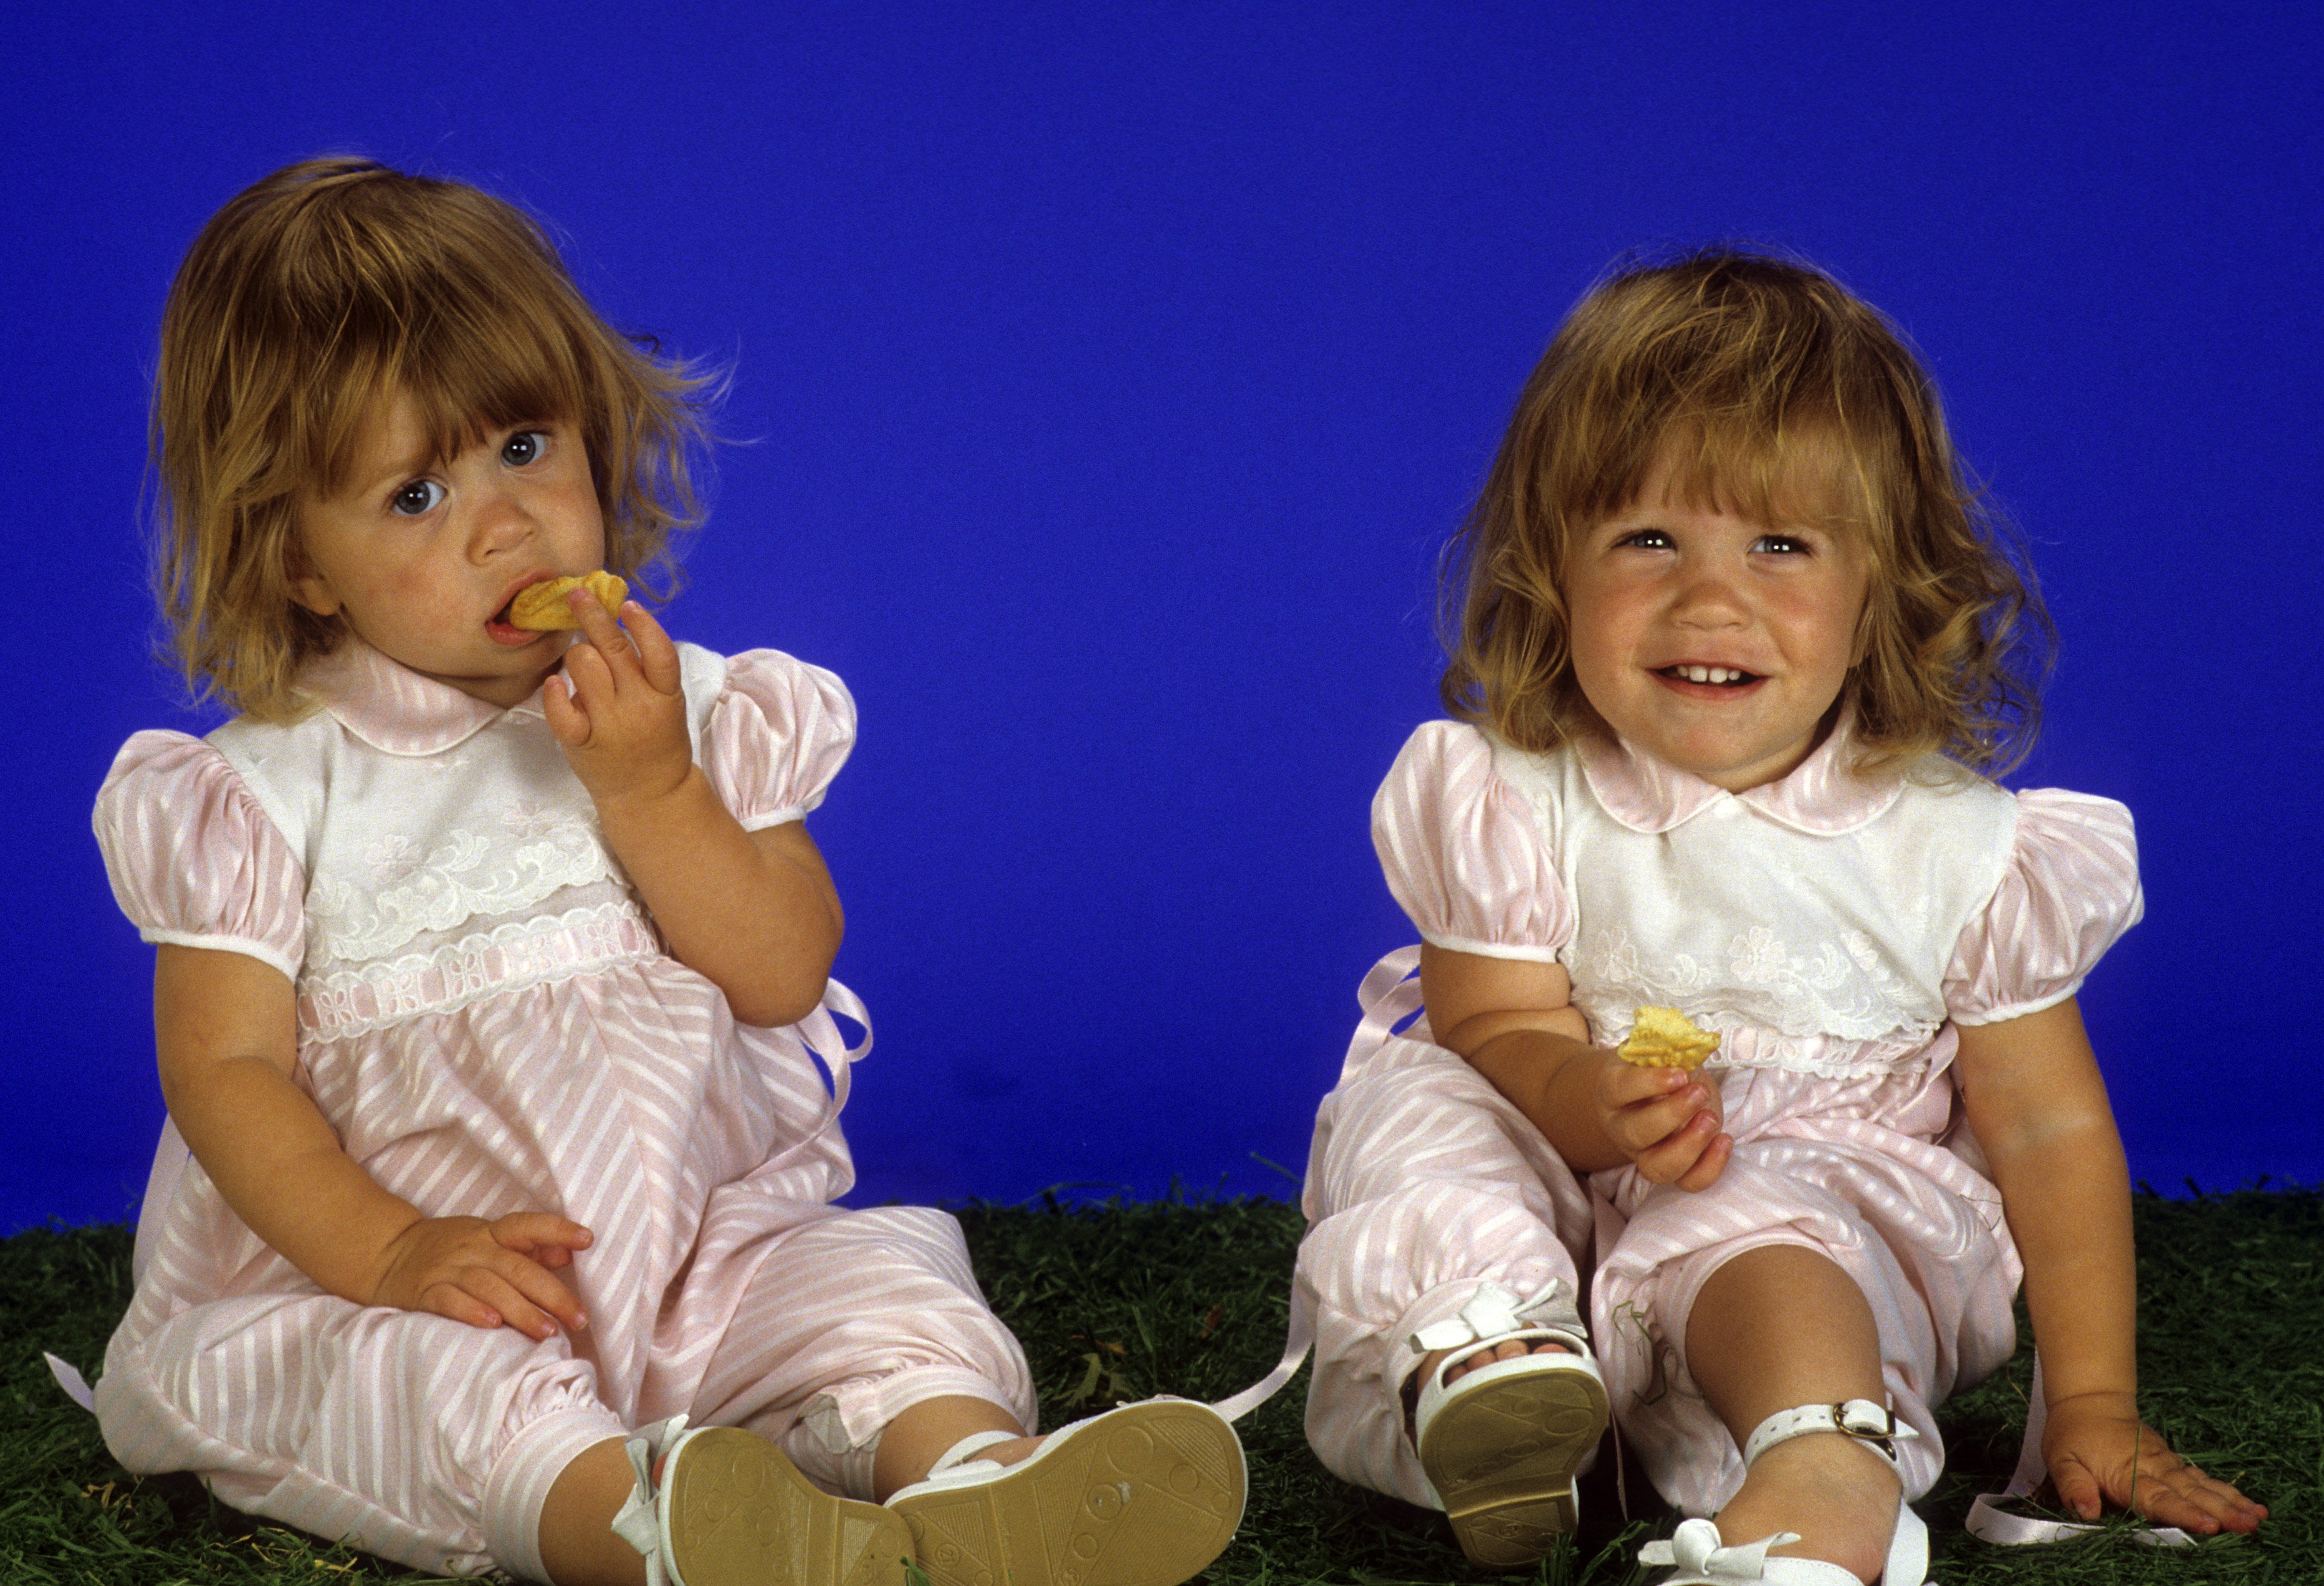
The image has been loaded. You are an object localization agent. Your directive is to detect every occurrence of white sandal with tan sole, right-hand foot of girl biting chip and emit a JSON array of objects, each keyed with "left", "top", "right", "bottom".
[{"left": 887, "top": 1398, "right": 1243, "bottom": 1586}]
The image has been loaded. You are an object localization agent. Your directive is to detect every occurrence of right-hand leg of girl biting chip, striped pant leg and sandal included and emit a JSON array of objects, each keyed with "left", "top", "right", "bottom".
[{"left": 674, "top": 1207, "right": 1243, "bottom": 1586}]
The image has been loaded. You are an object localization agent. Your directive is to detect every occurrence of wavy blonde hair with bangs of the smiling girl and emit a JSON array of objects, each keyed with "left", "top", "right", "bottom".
[{"left": 1441, "top": 247, "right": 2054, "bottom": 776}]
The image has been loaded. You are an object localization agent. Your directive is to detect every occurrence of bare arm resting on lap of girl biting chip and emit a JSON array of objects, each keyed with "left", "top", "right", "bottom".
[{"left": 153, "top": 944, "right": 588, "bottom": 1337}]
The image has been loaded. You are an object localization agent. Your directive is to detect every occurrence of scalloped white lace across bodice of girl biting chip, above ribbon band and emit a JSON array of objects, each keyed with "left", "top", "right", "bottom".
[{"left": 307, "top": 802, "right": 621, "bottom": 963}]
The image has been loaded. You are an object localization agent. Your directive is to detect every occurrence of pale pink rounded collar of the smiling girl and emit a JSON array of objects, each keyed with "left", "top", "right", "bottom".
[{"left": 1574, "top": 707, "right": 1903, "bottom": 837}]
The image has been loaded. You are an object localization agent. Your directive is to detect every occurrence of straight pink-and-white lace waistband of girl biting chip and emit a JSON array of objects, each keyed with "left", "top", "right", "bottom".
[{"left": 297, "top": 902, "right": 662, "bottom": 1039}]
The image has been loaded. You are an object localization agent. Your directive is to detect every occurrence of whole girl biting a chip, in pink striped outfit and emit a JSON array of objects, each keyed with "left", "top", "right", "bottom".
[{"left": 95, "top": 158, "right": 1243, "bottom": 1586}]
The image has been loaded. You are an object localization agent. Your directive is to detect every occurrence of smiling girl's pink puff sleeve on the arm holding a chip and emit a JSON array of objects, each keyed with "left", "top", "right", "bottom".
[{"left": 1371, "top": 721, "right": 1574, "bottom": 963}]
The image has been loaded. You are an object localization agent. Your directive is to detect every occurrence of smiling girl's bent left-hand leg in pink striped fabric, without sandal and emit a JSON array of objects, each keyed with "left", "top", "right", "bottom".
[{"left": 1297, "top": 1042, "right": 1590, "bottom": 1504}]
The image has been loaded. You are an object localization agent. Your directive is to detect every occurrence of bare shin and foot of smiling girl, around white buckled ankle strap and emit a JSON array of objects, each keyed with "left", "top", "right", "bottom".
[{"left": 1687, "top": 1244, "right": 1901, "bottom": 1579}]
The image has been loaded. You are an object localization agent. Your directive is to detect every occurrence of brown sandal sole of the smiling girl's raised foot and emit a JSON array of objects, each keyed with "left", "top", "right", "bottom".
[{"left": 1420, "top": 1372, "right": 1606, "bottom": 1570}]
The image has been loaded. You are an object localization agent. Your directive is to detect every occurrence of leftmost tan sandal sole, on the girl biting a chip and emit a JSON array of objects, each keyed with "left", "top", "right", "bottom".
[{"left": 664, "top": 1426, "right": 911, "bottom": 1586}]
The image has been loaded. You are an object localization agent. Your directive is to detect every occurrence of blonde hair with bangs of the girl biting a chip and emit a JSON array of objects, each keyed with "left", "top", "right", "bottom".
[{"left": 151, "top": 158, "right": 714, "bottom": 721}]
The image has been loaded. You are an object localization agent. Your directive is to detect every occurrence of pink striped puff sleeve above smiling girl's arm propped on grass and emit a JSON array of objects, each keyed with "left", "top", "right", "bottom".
[{"left": 1945, "top": 788, "right": 2145, "bottom": 1023}]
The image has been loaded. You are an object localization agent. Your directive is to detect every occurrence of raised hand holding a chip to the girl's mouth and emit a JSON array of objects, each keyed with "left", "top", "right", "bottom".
[{"left": 542, "top": 588, "right": 695, "bottom": 807}]
